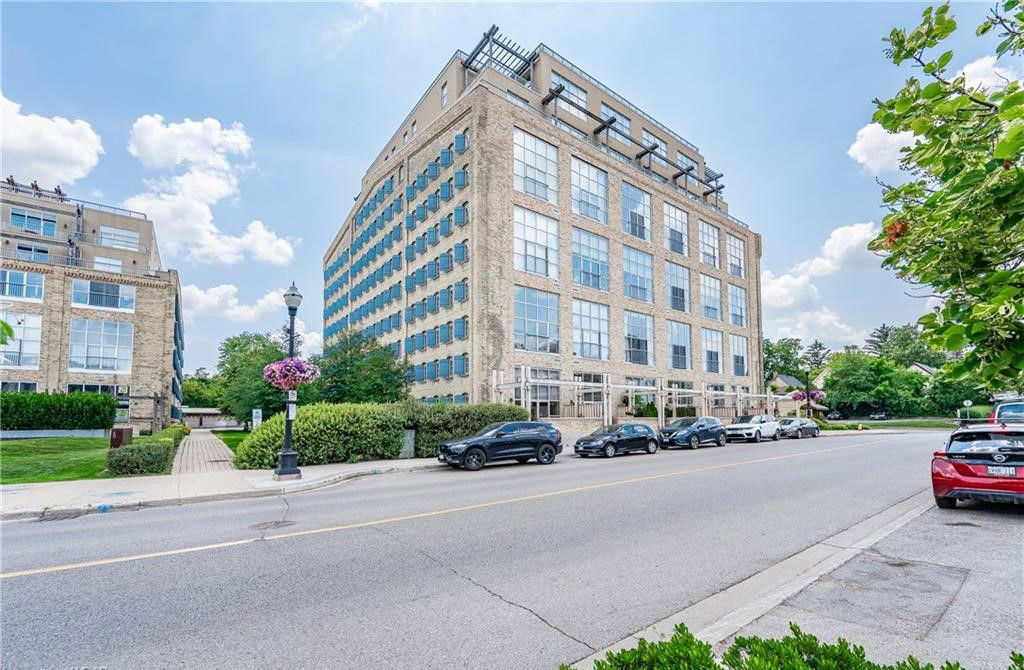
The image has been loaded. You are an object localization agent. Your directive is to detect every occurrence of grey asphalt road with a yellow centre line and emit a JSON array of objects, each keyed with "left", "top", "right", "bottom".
[{"left": 0, "top": 432, "right": 942, "bottom": 670}]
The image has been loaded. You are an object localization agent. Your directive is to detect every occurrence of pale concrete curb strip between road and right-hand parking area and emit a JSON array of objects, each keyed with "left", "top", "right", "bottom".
[{"left": 571, "top": 489, "right": 935, "bottom": 670}]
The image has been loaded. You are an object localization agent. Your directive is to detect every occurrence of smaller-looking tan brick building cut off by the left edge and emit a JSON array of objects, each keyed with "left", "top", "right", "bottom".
[{"left": 0, "top": 179, "right": 184, "bottom": 428}]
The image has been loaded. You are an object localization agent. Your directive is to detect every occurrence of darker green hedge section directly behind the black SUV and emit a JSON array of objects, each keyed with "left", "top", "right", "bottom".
[{"left": 397, "top": 401, "right": 529, "bottom": 458}]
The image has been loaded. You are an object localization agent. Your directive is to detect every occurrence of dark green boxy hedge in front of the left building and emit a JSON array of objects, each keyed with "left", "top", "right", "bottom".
[{"left": 0, "top": 392, "right": 118, "bottom": 430}]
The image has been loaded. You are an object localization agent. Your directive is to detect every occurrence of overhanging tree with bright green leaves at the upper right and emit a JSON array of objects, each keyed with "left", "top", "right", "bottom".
[{"left": 869, "top": 0, "right": 1024, "bottom": 388}]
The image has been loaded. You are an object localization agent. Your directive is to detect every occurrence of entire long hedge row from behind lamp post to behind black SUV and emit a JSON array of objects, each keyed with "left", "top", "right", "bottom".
[{"left": 234, "top": 401, "right": 529, "bottom": 469}]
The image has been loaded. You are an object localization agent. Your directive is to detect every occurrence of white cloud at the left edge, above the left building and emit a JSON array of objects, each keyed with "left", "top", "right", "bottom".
[{"left": 0, "top": 93, "right": 103, "bottom": 189}]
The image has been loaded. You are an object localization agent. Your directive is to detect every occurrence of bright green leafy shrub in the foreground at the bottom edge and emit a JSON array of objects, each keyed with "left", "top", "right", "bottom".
[{"left": 561, "top": 624, "right": 1024, "bottom": 670}]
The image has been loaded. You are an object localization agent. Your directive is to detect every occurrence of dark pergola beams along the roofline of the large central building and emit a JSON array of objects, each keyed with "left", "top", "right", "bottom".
[{"left": 462, "top": 26, "right": 725, "bottom": 207}]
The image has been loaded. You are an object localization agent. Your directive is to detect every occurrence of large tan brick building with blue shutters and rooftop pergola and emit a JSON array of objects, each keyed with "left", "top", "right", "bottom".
[{"left": 324, "top": 28, "right": 763, "bottom": 416}]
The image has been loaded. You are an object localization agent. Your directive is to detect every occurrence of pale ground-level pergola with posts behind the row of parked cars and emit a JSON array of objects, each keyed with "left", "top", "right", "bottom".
[{"left": 490, "top": 366, "right": 788, "bottom": 426}]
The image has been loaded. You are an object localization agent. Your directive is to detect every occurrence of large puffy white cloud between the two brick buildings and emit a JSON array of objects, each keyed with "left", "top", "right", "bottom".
[{"left": 125, "top": 115, "right": 298, "bottom": 265}]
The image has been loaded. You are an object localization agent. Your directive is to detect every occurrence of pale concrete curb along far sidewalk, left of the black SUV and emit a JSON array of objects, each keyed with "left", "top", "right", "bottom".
[{"left": 0, "top": 463, "right": 447, "bottom": 521}]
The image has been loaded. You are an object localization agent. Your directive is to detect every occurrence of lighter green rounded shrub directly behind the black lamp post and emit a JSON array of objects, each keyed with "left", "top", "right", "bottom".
[{"left": 234, "top": 403, "right": 403, "bottom": 469}]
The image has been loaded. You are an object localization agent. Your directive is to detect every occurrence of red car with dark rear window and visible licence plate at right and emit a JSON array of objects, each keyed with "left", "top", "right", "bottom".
[{"left": 932, "top": 422, "right": 1024, "bottom": 509}]
